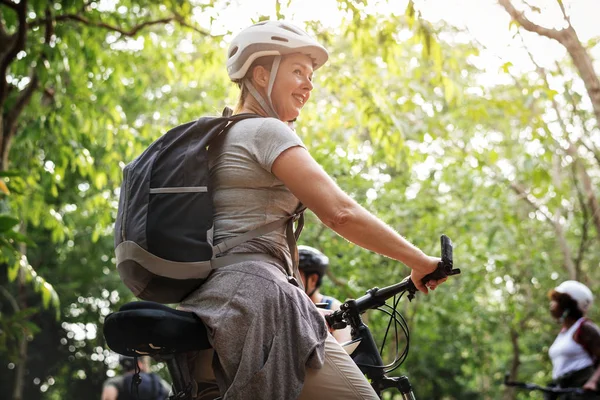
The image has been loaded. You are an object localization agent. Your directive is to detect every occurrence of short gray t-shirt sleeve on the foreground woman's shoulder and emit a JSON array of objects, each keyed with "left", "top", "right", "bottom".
[{"left": 249, "top": 118, "right": 306, "bottom": 172}]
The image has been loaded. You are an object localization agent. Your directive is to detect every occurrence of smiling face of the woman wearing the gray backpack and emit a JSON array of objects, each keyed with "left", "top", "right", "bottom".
[{"left": 271, "top": 53, "right": 313, "bottom": 121}]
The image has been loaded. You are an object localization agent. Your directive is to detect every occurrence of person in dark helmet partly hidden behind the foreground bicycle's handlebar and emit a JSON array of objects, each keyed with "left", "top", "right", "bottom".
[{"left": 298, "top": 245, "right": 352, "bottom": 343}]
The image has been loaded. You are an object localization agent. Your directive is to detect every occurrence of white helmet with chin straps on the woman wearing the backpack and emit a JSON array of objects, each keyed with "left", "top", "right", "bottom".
[{"left": 227, "top": 21, "right": 329, "bottom": 118}]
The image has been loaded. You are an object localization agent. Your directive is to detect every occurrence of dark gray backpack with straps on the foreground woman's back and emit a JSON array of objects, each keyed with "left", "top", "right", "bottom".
[{"left": 115, "top": 108, "right": 304, "bottom": 304}]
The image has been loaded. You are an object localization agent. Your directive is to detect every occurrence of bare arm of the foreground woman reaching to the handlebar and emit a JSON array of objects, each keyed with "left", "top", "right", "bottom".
[{"left": 272, "top": 147, "right": 439, "bottom": 293}]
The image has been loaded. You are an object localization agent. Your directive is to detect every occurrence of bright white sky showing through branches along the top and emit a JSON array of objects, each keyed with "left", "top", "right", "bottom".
[{"left": 203, "top": 0, "right": 600, "bottom": 83}]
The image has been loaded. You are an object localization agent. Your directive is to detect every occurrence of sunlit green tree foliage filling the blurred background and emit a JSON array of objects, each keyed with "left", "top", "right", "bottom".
[{"left": 0, "top": 0, "right": 600, "bottom": 399}]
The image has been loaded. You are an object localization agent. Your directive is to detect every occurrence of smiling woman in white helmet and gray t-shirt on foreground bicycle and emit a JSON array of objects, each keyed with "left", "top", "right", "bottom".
[{"left": 180, "top": 21, "right": 443, "bottom": 399}]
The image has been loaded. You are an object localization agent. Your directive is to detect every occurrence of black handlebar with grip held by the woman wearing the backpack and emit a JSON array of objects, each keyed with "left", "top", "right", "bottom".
[{"left": 325, "top": 235, "right": 460, "bottom": 329}]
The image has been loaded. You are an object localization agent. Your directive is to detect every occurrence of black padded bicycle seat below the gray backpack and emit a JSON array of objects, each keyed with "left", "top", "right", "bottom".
[{"left": 104, "top": 301, "right": 211, "bottom": 357}]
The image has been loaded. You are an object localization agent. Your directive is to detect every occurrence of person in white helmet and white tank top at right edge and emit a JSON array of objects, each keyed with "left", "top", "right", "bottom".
[{"left": 548, "top": 281, "right": 600, "bottom": 399}]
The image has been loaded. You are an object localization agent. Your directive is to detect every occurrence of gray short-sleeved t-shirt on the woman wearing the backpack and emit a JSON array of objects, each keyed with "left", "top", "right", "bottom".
[{"left": 209, "top": 118, "right": 304, "bottom": 265}]
